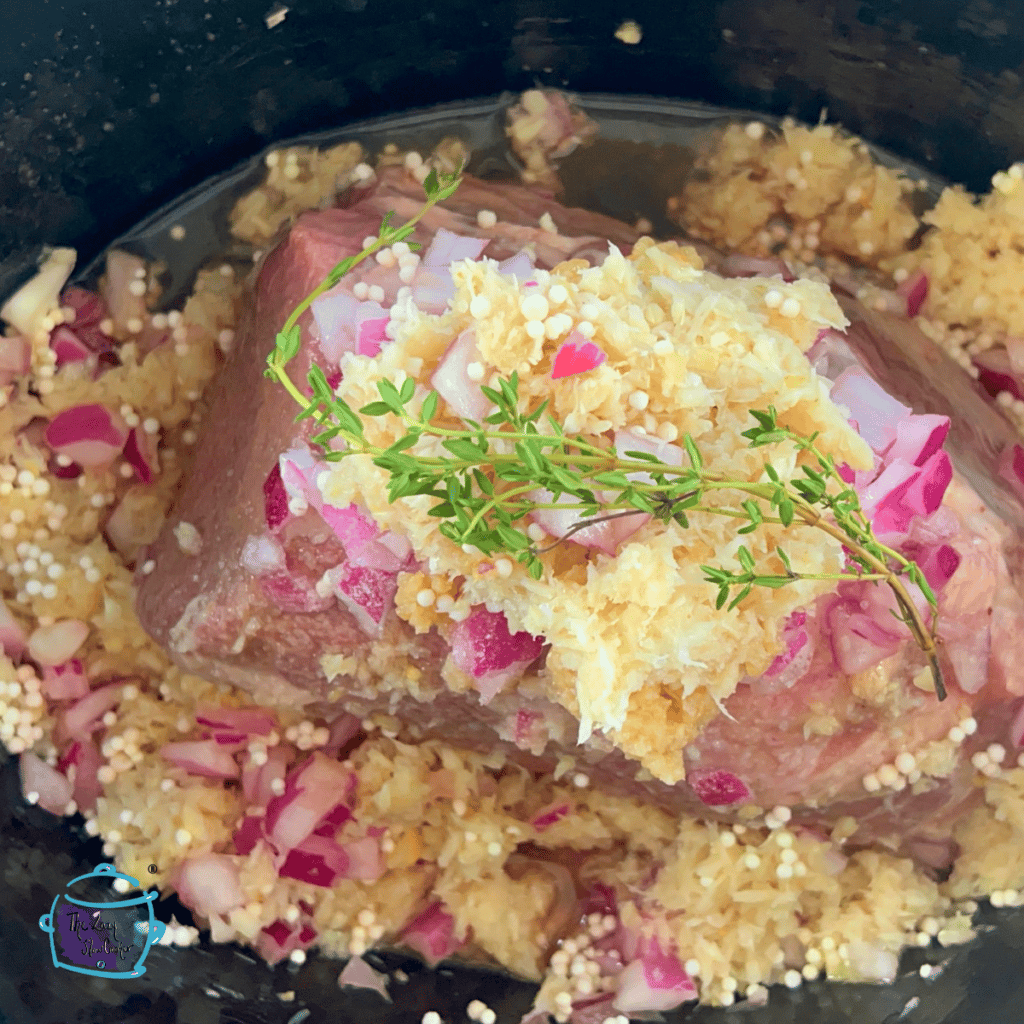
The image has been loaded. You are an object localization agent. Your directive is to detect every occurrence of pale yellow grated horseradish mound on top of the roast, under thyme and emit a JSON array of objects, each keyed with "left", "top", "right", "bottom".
[{"left": 318, "top": 239, "right": 871, "bottom": 783}]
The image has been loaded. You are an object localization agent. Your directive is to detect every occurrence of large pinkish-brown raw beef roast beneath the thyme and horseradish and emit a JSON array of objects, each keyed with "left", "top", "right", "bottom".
[{"left": 138, "top": 165, "right": 1024, "bottom": 867}]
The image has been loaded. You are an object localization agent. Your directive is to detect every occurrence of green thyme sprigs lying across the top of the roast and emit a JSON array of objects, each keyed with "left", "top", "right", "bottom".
[{"left": 267, "top": 178, "right": 946, "bottom": 699}]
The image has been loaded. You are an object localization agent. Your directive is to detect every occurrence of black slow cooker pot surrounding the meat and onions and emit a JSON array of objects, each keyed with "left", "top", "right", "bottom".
[{"left": 0, "top": 0, "right": 1024, "bottom": 1024}]
